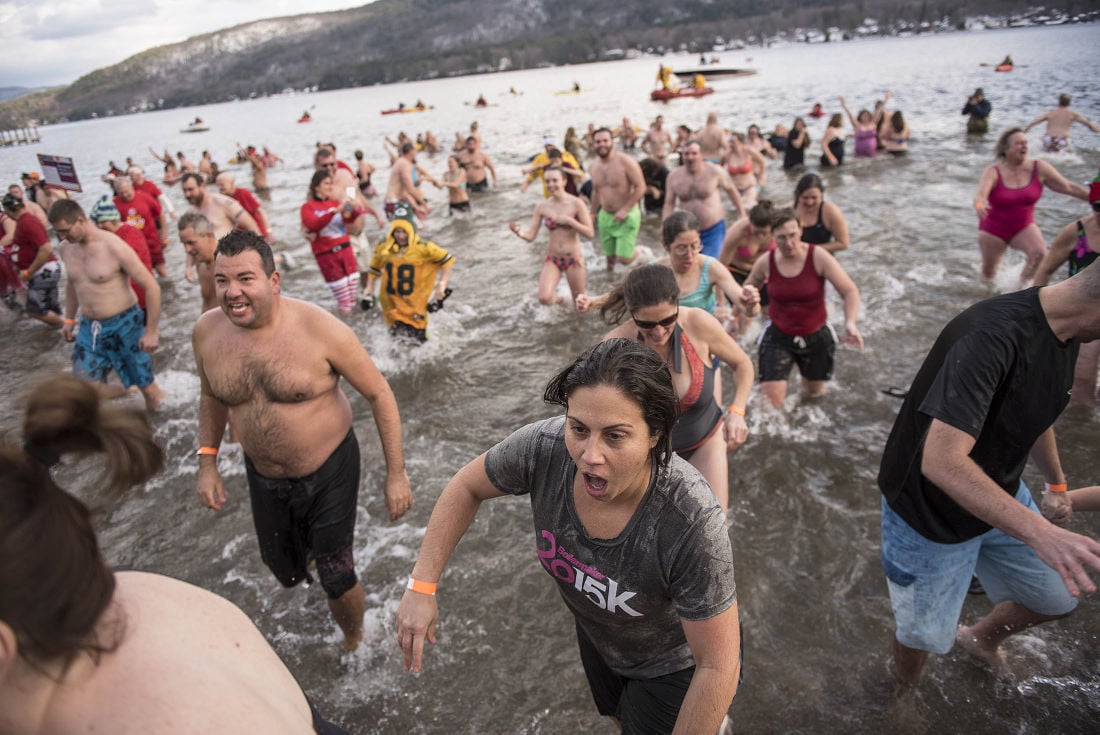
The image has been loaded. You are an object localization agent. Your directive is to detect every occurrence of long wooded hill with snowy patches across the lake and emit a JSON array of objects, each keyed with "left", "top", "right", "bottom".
[{"left": 0, "top": 0, "right": 1100, "bottom": 128}]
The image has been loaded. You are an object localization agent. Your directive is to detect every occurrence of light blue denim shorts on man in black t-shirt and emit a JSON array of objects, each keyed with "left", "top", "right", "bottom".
[{"left": 882, "top": 482, "right": 1077, "bottom": 654}]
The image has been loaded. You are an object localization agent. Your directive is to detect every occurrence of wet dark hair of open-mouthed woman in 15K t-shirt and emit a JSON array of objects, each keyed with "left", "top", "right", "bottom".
[{"left": 542, "top": 338, "right": 679, "bottom": 468}]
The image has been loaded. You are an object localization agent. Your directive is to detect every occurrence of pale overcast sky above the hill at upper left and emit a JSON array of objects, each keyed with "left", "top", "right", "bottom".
[{"left": 0, "top": 0, "right": 371, "bottom": 87}]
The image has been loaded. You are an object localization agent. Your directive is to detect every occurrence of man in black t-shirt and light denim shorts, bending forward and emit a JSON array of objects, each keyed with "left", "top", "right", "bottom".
[{"left": 879, "top": 268, "right": 1100, "bottom": 689}]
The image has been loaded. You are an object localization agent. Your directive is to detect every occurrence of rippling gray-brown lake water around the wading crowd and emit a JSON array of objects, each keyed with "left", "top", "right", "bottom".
[{"left": 0, "top": 24, "right": 1100, "bottom": 734}]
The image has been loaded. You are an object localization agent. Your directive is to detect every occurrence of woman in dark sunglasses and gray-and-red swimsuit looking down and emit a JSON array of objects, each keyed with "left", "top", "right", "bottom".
[{"left": 600, "top": 264, "right": 754, "bottom": 512}]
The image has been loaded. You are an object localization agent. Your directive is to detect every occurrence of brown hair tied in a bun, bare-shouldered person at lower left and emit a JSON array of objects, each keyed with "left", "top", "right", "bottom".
[{"left": 0, "top": 375, "right": 164, "bottom": 676}]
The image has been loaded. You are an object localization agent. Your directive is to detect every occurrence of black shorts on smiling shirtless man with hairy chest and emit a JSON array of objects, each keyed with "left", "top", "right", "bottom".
[{"left": 244, "top": 429, "right": 360, "bottom": 600}]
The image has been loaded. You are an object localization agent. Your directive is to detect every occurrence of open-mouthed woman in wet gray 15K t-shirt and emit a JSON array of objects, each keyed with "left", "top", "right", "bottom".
[{"left": 396, "top": 341, "right": 740, "bottom": 733}]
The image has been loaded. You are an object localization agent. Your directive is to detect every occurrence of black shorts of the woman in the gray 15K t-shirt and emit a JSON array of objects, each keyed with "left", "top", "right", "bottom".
[{"left": 576, "top": 626, "right": 695, "bottom": 735}]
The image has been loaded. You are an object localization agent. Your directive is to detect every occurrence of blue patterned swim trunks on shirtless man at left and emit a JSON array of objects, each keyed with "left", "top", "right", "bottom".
[{"left": 73, "top": 304, "right": 154, "bottom": 388}]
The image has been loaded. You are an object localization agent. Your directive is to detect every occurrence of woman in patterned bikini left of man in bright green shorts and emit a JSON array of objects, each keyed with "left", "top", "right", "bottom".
[{"left": 508, "top": 166, "right": 595, "bottom": 310}]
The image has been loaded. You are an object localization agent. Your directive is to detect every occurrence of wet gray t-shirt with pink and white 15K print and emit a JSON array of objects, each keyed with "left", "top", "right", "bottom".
[{"left": 485, "top": 416, "right": 737, "bottom": 679}]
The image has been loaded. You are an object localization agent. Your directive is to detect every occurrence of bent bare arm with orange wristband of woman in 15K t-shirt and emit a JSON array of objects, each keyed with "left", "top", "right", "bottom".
[{"left": 397, "top": 454, "right": 504, "bottom": 671}]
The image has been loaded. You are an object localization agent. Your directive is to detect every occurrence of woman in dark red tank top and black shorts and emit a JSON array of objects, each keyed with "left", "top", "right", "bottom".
[{"left": 745, "top": 209, "right": 864, "bottom": 408}]
